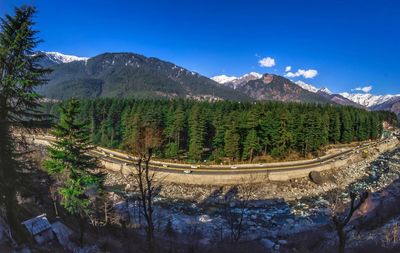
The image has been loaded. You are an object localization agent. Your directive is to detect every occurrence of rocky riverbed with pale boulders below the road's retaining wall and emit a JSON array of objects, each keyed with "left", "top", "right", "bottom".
[{"left": 101, "top": 144, "right": 400, "bottom": 250}]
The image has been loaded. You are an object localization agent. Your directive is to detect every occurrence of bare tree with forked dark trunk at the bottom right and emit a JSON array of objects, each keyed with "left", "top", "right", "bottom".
[{"left": 329, "top": 191, "right": 369, "bottom": 253}]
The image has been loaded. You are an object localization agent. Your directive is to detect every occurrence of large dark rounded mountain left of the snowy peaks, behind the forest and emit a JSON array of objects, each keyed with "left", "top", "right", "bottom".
[{"left": 39, "top": 53, "right": 251, "bottom": 101}]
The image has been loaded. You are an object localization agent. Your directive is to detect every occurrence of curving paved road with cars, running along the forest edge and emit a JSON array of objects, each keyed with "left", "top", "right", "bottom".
[{"left": 30, "top": 136, "right": 394, "bottom": 174}]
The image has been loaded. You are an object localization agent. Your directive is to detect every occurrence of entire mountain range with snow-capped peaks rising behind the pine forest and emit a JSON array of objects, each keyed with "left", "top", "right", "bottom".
[{"left": 39, "top": 52, "right": 397, "bottom": 113}]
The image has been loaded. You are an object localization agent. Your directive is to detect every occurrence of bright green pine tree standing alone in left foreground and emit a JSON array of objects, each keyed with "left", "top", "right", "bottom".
[{"left": 43, "top": 99, "right": 101, "bottom": 244}]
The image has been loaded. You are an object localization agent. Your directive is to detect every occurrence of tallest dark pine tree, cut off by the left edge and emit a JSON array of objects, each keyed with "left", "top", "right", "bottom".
[{"left": 0, "top": 6, "right": 50, "bottom": 240}]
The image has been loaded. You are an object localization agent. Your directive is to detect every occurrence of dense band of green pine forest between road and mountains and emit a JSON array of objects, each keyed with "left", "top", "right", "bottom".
[{"left": 47, "top": 99, "right": 396, "bottom": 160}]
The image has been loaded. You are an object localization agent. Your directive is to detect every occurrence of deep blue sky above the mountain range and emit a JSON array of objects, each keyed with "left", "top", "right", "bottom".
[{"left": 0, "top": 0, "right": 400, "bottom": 94}]
